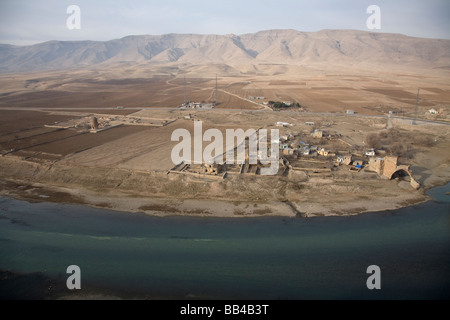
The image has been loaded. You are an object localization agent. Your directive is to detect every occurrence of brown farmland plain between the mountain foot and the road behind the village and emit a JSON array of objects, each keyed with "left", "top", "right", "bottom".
[{"left": 0, "top": 66, "right": 450, "bottom": 114}]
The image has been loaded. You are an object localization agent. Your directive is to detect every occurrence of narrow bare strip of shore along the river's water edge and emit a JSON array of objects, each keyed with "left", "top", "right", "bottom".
[{"left": 0, "top": 176, "right": 440, "bottom": 218}]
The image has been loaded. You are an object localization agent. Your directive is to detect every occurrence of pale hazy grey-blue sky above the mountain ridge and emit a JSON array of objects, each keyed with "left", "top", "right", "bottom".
[{"left": 0, "top": 0, "right": 450, "bottom": 45}]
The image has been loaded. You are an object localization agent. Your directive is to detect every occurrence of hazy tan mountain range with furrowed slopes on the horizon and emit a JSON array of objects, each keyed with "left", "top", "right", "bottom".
[{"left": 0, "top": 30, "right": 450, "bottom": 73}]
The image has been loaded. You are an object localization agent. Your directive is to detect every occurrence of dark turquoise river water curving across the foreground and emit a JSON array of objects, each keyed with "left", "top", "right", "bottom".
[{"left": 0, "top": 185, "right": 450, "bottom": 299}]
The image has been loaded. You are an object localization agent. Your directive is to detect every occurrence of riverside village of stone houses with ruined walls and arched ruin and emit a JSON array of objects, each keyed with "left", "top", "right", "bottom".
[{"left": 168, "top": 114, "right": 420, "bottom": 190}]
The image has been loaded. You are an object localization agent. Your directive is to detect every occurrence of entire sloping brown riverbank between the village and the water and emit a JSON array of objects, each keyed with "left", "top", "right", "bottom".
[{"left": 0, "top": 157, "right": 442, "bottom": 218}]
